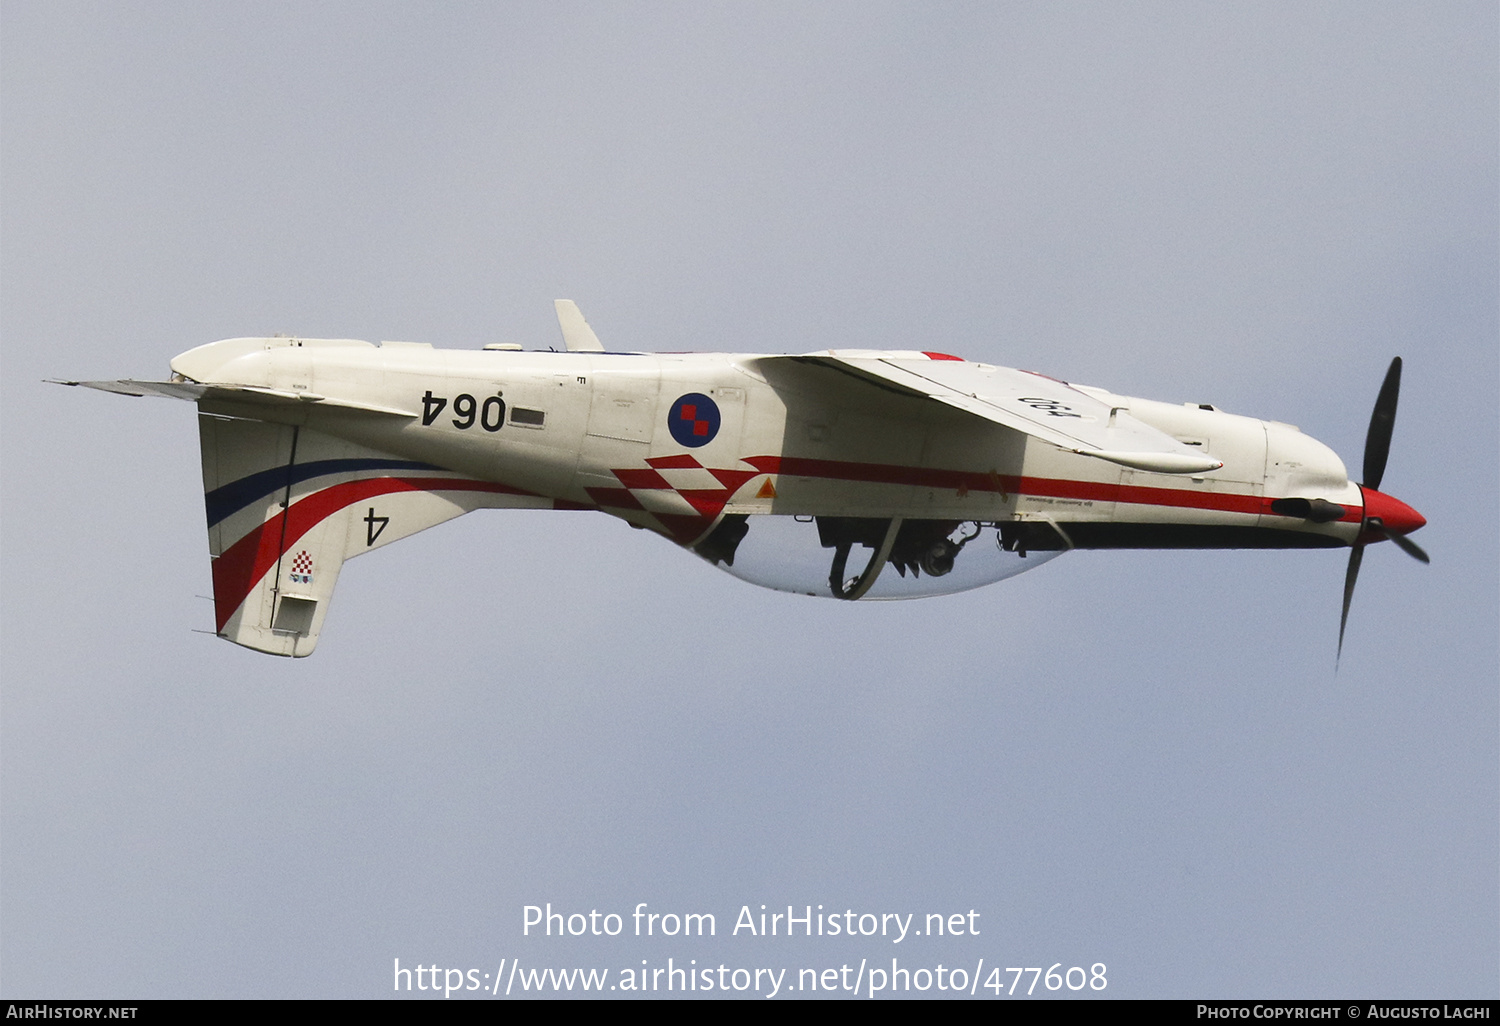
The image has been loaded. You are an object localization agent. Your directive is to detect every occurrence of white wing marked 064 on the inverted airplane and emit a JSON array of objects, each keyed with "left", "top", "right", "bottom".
[{"left": 762, "top": 350, "right": 1224, "bottom": 474}]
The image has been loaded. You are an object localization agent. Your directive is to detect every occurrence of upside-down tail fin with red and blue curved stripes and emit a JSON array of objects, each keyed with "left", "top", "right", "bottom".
[{"left": 198, "top": 414, "right": 552, "bottom": 656}]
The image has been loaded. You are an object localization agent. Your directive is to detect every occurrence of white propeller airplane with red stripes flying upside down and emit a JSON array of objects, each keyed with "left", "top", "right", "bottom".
[{"left": 57, "top": 300, "right": 1428, "bottom": 657}]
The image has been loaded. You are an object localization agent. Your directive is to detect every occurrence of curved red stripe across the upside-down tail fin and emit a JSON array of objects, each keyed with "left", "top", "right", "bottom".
[{"left": 213, "top": 477, "right": 534, "bottom": 632}]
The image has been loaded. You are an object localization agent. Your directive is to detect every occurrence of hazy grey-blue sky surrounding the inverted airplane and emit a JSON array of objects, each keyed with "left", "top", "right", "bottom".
[{"left": 0, "top": 0, "right": 1500, "bottom": 998}]
